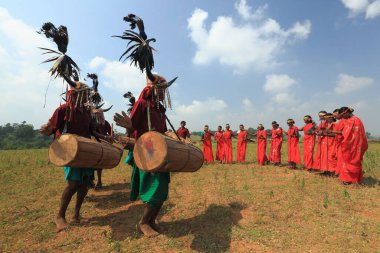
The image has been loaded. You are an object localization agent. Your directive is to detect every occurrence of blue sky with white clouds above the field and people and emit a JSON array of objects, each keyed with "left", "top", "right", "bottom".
[{"left": 0, "top": 0, "right": 380, "bottom": 136}]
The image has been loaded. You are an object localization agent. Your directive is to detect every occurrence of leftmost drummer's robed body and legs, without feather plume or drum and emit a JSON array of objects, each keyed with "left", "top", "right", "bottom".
[{"left": 40, "top": 79, "right": 111, "bottom": 232}]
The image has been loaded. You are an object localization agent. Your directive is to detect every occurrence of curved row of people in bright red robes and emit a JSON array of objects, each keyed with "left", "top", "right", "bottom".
[{"left": 186, "top": 107, "right": 368, "bottom": 184}]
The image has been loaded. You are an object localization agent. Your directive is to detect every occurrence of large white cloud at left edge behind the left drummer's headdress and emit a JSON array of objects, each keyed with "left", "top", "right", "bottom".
[{"left": 0, "top": 7, "right": 67, "bottom": 127}]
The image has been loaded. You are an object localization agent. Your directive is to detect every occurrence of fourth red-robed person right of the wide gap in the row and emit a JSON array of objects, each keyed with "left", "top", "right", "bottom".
[{"left": 300, "top": 115, "right": 316, "bottom": 171}]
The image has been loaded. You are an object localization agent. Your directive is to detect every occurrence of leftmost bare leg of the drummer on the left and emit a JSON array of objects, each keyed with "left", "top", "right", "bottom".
[{"left": 55, "top": 180, "right": 77, "bottom": 232}]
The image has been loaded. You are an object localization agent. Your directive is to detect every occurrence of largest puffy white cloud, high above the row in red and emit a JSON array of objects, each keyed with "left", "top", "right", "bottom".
[{"left": 188, "top": 1, "right": 311, "bottom": 73}]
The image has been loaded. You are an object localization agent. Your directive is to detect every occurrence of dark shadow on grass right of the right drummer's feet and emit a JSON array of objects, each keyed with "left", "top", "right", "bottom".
[{"left": 160, "top": 202, "right": 245, "bottom": 252}]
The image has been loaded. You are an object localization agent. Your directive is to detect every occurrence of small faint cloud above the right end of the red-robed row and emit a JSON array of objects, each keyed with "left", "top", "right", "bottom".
[{"left": 334, "top": 74, "right": 373, "bottom": 95}]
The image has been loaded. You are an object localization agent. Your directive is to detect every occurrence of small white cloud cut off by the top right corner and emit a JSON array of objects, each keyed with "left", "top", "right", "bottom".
[{"left": 341, "top": 0, "right": 380, "bottom": 19}]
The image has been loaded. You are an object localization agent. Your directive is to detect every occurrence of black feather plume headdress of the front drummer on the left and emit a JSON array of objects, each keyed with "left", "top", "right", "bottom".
[{"left": 37, "top": 22, "right": 80, "bottom": 83}]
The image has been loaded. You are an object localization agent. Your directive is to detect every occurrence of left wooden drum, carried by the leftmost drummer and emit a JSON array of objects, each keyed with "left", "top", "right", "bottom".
[{"left": 49, "top": 134, "right": 123, "bottom": 169}]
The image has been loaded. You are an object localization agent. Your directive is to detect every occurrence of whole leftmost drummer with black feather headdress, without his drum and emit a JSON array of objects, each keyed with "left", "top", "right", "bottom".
[{"left": 39, "top": 22, "right": 111, "bottom": 232}]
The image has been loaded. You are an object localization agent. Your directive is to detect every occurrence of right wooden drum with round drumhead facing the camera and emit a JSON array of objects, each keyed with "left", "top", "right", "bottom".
[{"left": 133, "top": 131, "right": 204, "bottom": 172}]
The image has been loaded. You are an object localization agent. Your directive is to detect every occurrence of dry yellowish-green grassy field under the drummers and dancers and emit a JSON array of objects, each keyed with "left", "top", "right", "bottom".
[{"left": 0, "top": 143, "right": 380, "bottom": 252}]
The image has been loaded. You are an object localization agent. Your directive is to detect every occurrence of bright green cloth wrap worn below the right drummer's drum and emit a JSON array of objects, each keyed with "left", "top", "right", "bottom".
[{"left": 130, "top": 152, "right": 170, "bottom": 208}]
